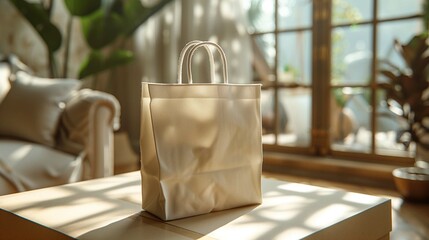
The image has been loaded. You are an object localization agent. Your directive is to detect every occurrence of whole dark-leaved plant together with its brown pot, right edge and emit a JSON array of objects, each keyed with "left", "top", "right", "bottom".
[{"left": 381, "top": 32, "right": 429, "bottom": 201}]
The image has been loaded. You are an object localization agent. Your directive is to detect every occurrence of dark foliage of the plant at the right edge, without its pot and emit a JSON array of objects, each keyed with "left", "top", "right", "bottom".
[{"left": 380, "top": 0, "right": 429, "bottom": 164}]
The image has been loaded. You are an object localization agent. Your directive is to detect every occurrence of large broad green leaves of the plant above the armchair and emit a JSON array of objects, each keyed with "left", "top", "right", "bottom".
[{"left": 9, "top": 0, "right": 172, "bottom": 79}]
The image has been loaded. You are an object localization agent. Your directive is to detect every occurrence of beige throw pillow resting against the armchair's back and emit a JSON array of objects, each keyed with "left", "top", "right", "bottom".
[{"left": 0, "top": 71, "right": 80, "bottom": 147}]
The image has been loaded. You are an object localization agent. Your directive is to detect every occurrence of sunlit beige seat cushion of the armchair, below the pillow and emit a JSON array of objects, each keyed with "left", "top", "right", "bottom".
[{"left": 0, "top": 139, "right": 82, "bottom": 195}]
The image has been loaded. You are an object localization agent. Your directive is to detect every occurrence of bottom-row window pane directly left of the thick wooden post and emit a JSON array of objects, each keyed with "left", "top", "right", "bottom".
[{"left": 278, "top": 88, "right": 311, "bottom": 147}]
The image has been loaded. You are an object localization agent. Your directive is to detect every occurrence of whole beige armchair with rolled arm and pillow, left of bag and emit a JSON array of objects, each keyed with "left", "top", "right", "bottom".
[{"left": 0, "top": 55, "right": 120, "bottom": 195}]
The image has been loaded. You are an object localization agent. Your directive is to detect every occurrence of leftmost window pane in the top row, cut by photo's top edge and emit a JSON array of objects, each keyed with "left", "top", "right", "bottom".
[{"left": 243, "top": 0, "right": 275, "bottom": 32}]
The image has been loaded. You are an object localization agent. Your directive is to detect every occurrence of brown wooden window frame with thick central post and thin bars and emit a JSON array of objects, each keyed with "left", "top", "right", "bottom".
[{"left": 251, "top": 0, "right": 420, "bottom": 166}]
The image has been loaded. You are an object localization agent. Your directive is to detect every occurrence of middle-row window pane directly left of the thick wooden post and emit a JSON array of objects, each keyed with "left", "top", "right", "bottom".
[{"left": 277, "top": 31, "right": 312, "bottom": 84}]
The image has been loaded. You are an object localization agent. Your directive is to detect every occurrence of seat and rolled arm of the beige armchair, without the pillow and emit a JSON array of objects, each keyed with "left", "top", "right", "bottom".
[{"left": 0, "top": 89, "right": 120, "bottom": 195}]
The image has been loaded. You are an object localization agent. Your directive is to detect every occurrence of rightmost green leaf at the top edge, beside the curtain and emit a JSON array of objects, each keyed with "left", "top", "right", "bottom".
[{"left": 123, "top": 0, "right": 173, "bottom": 36}]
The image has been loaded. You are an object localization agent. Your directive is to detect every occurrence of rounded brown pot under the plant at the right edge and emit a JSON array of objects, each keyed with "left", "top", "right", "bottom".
[{"left": 393, "top": 167, "right": 429, "bottom": 201}]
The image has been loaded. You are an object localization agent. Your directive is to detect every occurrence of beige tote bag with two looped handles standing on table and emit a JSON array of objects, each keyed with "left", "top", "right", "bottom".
[{"left": 140, "top": 41, "right": 262, "bottom": 220}]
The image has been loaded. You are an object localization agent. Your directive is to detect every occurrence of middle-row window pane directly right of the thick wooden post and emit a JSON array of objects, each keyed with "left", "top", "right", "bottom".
[{"left": 331, "top": 25, "right": 372, "bottom": 84}]
